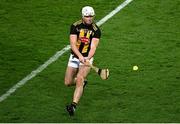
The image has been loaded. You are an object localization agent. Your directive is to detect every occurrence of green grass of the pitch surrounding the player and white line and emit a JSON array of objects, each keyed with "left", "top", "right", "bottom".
[{"left": 0, "top": 0, "right": 180, "bottom": 122}]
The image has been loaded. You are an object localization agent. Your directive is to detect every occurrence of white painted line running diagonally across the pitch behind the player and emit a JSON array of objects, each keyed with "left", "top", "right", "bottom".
[{"left": 0, "top": 0, "right": 133, "bottom": 102}]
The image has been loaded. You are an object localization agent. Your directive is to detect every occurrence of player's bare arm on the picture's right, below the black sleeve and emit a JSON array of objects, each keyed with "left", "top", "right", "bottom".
[{"left": 87, "top": 38, "right": 99, "bottom": 60}]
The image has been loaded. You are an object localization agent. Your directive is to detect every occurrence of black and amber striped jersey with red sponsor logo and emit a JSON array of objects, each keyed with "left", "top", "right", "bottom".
[{"left": 70, "top": 20, "right": 101, "bottom": 57}]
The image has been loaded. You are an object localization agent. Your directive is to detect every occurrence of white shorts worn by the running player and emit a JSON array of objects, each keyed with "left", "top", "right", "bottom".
[{"left": 68, "top": 54, "right": 94, "bottom": 68}]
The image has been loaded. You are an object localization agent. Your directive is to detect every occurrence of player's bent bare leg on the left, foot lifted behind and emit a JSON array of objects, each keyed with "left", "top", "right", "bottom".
[{"left": 64, "top": 66, "right": 78, "bottom": 86}]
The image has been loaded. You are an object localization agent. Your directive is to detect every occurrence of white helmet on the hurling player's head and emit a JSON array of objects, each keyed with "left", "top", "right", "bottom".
[{"left": 82, "top": 6, "right": 95, "bottom": 17}]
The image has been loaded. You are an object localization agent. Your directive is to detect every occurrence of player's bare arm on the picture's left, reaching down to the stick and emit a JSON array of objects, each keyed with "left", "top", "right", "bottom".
[{"left": 70, "top": 34, "right": 84, "bottom": 63}]
